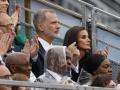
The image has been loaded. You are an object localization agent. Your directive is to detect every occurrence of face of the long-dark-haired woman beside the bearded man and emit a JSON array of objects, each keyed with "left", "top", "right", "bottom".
[{"left": 77, "top": 30, "right": 91, "bottom": 50}]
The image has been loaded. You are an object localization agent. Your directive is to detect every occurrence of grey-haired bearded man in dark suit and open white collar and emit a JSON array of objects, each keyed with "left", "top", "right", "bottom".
[{"left": 31, "top": 9, "right": 60, "bottom": 77}]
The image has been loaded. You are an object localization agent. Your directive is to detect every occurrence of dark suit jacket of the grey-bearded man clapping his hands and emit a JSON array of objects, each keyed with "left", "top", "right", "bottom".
[{"left": 31, "top": 42, "right": 45, "bottom": 78}]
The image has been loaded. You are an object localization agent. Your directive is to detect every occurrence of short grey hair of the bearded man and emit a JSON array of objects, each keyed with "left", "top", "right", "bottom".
[{"left": 33, "top": 9, "right": 55, "bottom": 30}]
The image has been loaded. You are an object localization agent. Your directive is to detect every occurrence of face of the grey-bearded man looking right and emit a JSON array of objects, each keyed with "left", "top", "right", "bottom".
[{"left": 41, "top": 12, "right": 60, "bottom": 38}]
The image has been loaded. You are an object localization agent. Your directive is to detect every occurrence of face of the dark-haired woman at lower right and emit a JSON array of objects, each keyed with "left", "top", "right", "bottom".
[{"left": 95, "top": 59, "right": 112, "bottom": 75}]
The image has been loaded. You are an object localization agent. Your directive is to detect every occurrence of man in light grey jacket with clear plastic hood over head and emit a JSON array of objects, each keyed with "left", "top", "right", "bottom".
[{"left": 36, "top": 46, "right": 75, "bottom": 85}]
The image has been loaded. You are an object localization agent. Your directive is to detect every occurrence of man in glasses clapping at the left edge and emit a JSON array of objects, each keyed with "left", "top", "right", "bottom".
[{"left": 0, "top": 13, "right": 15, "bottom": 64}]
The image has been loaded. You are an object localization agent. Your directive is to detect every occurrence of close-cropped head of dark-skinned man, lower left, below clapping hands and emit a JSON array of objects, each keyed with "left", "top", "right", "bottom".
[{"left": 5, "top": 52, "right": 31, "bottom": 77}]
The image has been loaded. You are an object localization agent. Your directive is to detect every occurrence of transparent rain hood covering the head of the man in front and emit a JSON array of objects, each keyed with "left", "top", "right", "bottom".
[{"left": 45, "top": 46, "right": 71, "bottom": 76}]
